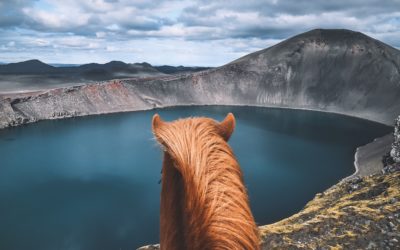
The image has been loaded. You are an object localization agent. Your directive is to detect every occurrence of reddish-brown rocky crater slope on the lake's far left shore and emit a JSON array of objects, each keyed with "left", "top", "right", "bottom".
[{"left": 0, "top": 82, "right": 149, "bottom": 128}]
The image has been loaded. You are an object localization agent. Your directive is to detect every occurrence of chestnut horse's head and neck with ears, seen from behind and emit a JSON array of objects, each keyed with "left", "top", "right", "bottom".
[{"left": 152, "top": 113, "right": 259, "bottom": 250}]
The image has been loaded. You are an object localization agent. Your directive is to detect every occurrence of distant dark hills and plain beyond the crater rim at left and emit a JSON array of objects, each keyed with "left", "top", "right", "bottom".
[{"left": 0, "top": 59, "right": 209, "bottom": 93}]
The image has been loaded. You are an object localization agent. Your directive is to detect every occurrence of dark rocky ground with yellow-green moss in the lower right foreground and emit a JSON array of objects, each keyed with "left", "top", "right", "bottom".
[{"left": 260, "top": 170, "right": 400, "bottom": 249}]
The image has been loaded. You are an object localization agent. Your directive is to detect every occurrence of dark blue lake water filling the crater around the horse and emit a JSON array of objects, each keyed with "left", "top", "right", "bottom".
[{"left": 0, "top": 106, "right": 391, "bottom": 249}]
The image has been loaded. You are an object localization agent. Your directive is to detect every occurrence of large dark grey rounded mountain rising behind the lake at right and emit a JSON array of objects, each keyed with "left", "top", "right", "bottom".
[{"left": 122, "top": 29, "right": 400, "bottom": 124}]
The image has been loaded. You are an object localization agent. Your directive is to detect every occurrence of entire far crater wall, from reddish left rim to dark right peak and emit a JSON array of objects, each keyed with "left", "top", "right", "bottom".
[{"left": 0, "top": 30, "right": 400, "bottom": 127}]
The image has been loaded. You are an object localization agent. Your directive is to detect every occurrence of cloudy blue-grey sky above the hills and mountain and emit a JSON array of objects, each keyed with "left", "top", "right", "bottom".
[{"left": 0, "top": 0, "right": 400, "bottom": 66}]
